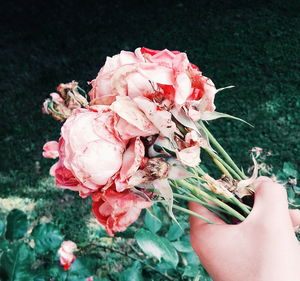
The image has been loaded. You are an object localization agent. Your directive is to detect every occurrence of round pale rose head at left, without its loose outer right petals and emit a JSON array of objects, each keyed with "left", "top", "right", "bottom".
[{"left": 47, "top": 106, "right": 127, "bottom": 197}]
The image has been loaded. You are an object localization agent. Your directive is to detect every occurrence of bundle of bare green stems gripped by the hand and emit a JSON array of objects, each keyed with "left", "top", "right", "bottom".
[{"left": 169, "top": 121, "right": 251, "bottom": 223}]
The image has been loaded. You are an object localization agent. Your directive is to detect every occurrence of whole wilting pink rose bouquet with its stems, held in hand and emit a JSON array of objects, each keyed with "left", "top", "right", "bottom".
[{"left": 43, "top": 48, "right": 257, "bottom": 236}]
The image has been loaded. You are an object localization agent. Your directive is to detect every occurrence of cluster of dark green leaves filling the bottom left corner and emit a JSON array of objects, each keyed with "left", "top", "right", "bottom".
[{"left": 0, "top": 209, "right": 101, "bottom": 281}]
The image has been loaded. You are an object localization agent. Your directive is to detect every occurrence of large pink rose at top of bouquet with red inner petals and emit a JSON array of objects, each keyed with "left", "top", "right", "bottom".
[{"left": 89, "top": 48, "right": 217, "bottom": 106}]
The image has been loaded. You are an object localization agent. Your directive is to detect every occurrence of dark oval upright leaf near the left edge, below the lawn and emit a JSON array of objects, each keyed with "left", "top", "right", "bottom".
[{"left": 5, "top": 209, "right": 28, "bottom": 240}]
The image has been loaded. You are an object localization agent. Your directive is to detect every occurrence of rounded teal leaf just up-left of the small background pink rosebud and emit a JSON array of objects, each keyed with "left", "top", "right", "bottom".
[{"left": 31, "top": 223, "right": 63, "bottom": 254}]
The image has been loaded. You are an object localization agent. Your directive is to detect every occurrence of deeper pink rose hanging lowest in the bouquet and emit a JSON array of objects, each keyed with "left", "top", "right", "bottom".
[{"left": 92, "top": 186, "right": 153, "bottom": 236}]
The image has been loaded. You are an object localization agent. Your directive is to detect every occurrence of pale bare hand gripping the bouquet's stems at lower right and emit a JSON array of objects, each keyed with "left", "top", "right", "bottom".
[{"left": 190, "top": 177, "right": 300, "bottom": 281}]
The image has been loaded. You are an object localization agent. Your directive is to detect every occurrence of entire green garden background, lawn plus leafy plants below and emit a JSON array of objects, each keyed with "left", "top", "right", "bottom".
[{"left": 0, "top": 0, "right": 300, "bottom": 281}]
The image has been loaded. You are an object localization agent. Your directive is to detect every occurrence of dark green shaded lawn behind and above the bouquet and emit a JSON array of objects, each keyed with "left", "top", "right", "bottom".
[{"left": 0, "top": 0, "right": 300, "bottom": 191}]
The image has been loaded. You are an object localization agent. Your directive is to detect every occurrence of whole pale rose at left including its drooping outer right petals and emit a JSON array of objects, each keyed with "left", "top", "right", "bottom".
[{"left": 43, "top": 105, "right": 157, "bottom": 197}]
